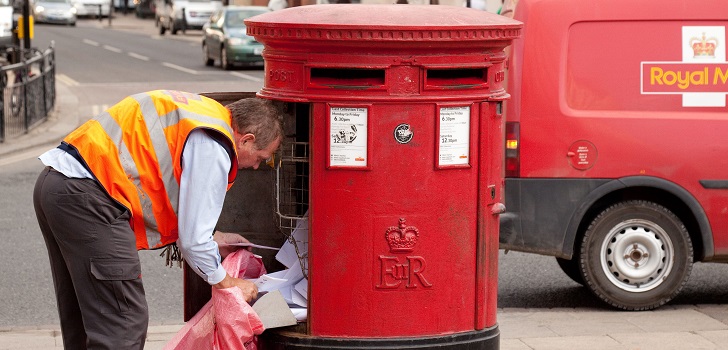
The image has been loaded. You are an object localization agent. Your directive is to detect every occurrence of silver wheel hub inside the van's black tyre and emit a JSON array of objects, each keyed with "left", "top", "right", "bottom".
[{"left": 600, "top": 219, "right": 675, "bottom": 293}]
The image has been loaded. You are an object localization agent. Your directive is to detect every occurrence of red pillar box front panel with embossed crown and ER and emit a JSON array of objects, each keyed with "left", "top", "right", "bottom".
[{"left": 308, "top": 103, "right": 480, "bottom": 337}]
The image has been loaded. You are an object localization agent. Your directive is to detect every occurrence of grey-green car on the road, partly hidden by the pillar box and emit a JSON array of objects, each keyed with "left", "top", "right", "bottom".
[{"left": 202, "top": 6, "right": 270, "bottom": 69}]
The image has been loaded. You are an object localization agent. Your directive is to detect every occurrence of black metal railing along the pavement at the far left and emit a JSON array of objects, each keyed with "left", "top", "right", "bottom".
[{"left": 0, "top": 43, "right": 56, "bottom": 143}]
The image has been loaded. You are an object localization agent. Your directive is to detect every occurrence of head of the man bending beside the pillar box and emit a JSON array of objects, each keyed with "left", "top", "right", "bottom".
[{"left": 226, "top": 97, "right": 283, "bottom": 169}]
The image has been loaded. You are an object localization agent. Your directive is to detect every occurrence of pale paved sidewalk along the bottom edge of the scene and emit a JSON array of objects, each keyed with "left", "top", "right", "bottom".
[{"left": 0, "top": 305, "right": 728, "bottom": 350}]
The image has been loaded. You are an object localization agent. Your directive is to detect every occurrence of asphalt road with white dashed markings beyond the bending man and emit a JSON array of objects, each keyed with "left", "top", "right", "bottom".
[{"left": 31, "top": 14, "right": 263, "bottom": 126}]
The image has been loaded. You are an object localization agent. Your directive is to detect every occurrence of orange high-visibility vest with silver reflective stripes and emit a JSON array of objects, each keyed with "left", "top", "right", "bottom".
[{"left": 64, "top": 90, "right": 238, "bottom": 249}]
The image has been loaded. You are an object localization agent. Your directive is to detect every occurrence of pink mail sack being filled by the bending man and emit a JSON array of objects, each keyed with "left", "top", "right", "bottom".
[{"left": 164, "top": 249, "right": 266, "bottom": 350}]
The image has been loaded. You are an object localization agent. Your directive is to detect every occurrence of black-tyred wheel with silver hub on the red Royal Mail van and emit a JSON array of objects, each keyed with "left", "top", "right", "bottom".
[{"left": 579, "top": 200, "right": 693, "bottom": 310}]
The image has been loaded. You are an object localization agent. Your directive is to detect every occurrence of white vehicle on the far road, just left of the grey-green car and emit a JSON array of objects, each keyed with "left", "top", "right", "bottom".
[{"left": 155, "top": 0, "right": 222, "bottom": 35}]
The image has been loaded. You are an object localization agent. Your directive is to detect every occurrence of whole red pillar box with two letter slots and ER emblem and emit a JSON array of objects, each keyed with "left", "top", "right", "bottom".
[{"left": 246, "top": 5, "right": 521, "bottom": 350}]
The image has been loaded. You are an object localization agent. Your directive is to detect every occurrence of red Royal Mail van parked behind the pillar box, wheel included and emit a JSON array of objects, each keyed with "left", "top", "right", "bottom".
[{"left": 500, "top": 0, "right": 728, "bottom": 310}]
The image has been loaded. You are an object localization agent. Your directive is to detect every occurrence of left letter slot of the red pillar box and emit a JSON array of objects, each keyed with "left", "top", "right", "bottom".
[{"left": 310, "top": 68, "right": 384, "bottom": 89}]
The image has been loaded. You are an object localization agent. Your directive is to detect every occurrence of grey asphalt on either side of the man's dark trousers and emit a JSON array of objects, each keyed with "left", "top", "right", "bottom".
[{"left": 0, "top": 156, "right": 188, "bottom": 328}]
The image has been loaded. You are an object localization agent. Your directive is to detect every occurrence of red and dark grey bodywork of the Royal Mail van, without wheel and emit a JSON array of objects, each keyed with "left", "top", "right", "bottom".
[{"left": 501, "top": 0, "right": 728, "bottom": 261}]
